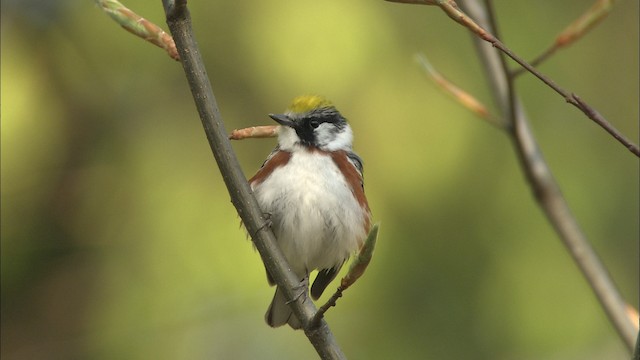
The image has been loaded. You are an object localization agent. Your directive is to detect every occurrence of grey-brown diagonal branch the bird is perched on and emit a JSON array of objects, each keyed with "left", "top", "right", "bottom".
[{"left": 163, "top": 0, "right": 345, "bottom": 359}]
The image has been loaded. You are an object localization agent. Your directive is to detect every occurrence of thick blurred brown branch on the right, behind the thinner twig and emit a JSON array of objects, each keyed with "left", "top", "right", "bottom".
[{"left": 461, "top": 0, "right": 636, "bottom": 350}]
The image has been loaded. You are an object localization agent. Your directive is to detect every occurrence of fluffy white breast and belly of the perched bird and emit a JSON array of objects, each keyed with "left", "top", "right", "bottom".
[{"left": 253, "top": 150, "right": 367, "bottom": 278}]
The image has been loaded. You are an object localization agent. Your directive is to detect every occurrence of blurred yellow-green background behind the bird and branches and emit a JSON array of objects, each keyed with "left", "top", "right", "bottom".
[{"left": 1, "top": 0, "right": 640, "bottom": 359}]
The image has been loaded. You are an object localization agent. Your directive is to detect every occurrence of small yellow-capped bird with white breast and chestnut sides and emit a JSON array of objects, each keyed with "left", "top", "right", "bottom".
[{"left": 249, "top": 95, "right": 371, "bottom": 329}]
